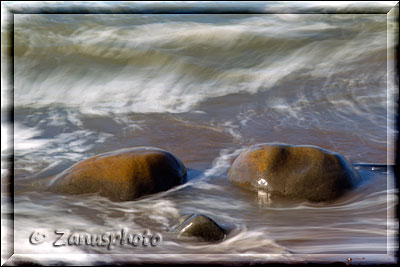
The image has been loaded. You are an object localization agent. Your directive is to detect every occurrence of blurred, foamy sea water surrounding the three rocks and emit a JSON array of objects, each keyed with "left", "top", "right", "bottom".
[{"left": 2, "top": 1, "right": 397, "bottom": 264}]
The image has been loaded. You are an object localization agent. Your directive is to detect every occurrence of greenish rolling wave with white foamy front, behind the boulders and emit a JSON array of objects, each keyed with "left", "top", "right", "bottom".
[{"left": 15, "top": 15, "right": 386, "bottom": 114}]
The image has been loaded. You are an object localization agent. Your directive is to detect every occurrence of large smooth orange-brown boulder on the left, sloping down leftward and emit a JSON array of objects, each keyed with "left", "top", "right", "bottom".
[{"left": 49, "top": 147, "right": 186, "bottom": 201}]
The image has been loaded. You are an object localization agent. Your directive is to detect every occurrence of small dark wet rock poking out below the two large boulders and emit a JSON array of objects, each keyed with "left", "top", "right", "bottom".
[{"left": 173, "top": 213, "right": 225, "bottom": 244}]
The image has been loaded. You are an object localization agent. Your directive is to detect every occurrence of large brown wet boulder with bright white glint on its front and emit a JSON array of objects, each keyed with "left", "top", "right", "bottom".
[{"left": 228, "top": 144, "right": 360, "bottom": 202}]
